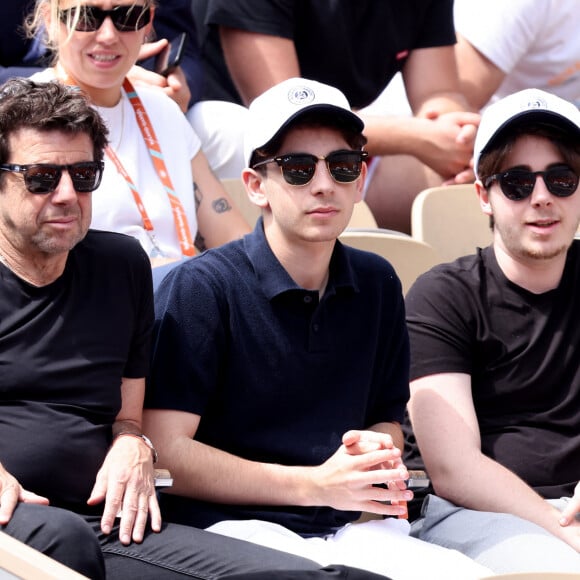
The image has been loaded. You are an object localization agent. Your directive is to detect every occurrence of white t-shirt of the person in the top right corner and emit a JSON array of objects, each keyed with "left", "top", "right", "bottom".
[{"left": 454, "top": 0, "right": 580, "bottom": 106}]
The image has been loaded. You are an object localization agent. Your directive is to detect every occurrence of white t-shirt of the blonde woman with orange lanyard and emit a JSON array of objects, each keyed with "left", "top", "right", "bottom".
[{"left": 33, "top": 69, "right": 201, "bottom": 258}]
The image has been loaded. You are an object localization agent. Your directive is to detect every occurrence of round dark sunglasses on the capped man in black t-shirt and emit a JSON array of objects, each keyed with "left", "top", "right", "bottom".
[{"left": 484, "top": 165, "right": 578, "bottom": 201}]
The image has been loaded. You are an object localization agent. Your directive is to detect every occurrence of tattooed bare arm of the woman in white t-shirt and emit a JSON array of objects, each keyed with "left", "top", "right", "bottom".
[{"left": 191, "top": 151, "right": 250, "bottom": 249}]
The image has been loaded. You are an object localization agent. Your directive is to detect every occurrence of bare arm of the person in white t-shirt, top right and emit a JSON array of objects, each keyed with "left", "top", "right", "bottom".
[{"left": 455, "top": 34, "right": 505, "bottom": 111}]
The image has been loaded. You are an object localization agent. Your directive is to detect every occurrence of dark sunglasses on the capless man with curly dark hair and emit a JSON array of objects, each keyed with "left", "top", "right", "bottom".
[{"left": 0, "top": 161, "right": 104, "bottom": 194}]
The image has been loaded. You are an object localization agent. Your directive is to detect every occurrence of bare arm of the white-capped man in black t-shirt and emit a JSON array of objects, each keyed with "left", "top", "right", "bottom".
[{"left": 409, "top": 373, "right": 580, "bottom": 550}]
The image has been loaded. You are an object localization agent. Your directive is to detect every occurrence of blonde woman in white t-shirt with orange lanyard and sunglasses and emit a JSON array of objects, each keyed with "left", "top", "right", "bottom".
[{"left": 30, "top": 0, "right": 249, "bottom": 265}]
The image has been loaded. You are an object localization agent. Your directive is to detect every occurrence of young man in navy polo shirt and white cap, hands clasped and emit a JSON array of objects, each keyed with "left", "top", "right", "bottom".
[{"left": 146, "top": 79, "right": 489, "bottom": 580}]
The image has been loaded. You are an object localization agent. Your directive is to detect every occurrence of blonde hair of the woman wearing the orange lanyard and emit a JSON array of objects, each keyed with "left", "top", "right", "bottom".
[{"left": 25, "top": 0, "right": 156, "bottom": 56}]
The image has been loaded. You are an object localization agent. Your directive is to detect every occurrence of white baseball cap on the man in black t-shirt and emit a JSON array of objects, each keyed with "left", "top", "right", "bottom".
[{"left": 473, "top": 89, "right": 580, "bottom": 177}]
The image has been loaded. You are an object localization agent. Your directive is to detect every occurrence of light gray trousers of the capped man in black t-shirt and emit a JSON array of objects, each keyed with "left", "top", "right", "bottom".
[{"left": 411, "top": 495, "right": 580, "bottom": 573}]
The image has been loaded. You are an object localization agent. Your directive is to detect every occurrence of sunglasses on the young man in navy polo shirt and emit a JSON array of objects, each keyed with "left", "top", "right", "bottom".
[{"left": 253, "top": 149, "right": 369, "bottom": 185}]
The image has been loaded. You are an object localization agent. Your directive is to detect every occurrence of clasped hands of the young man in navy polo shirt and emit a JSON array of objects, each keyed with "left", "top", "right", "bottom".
[{"left": 313, "top": 431, "right": 413, "bottom": 516}]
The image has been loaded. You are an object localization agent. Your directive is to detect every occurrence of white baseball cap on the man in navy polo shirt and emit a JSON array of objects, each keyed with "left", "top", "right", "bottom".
[{"left": 244, "top": 78, "right": 364, "bottom": 164}]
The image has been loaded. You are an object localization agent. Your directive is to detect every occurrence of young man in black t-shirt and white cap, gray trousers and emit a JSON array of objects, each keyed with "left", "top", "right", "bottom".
[{"left": 406, "top": 89, "right": 580, "bottom": 572}]
